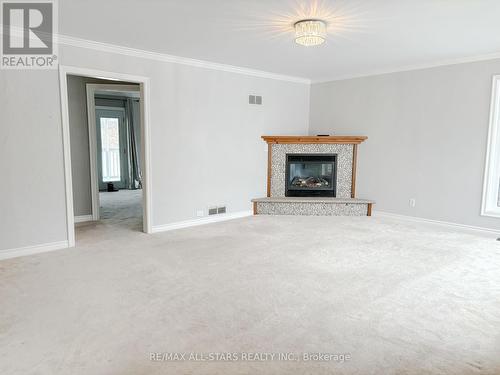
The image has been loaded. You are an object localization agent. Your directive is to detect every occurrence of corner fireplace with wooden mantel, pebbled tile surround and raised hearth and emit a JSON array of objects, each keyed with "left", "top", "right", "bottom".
[{"left": 252, "top": 136, "right": 374, "bottom": 216}]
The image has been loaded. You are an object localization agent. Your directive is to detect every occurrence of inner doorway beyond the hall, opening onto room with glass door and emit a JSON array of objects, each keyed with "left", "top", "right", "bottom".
[{"left": 86, "top": 83, "right": 143, "bottom": 228}]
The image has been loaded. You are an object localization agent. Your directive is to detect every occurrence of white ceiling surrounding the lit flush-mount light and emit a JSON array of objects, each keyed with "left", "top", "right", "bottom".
[{"left": 59, "top": 0, "right": 500, "bottom": 81}]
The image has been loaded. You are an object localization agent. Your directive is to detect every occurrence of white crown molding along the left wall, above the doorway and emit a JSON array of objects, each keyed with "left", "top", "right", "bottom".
[{"left": 57, "top": 34, "right": 311, "bottom": 85}]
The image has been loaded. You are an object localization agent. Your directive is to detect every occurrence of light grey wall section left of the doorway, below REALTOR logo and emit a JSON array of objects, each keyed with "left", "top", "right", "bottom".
[{"left": 0, "top": 70, "right": 67, "bottom": 249}]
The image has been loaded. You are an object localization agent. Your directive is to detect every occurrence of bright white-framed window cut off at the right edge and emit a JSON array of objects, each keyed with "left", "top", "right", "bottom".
[{"left": 481, "top": 75, "right": 500, "bottom": 217}]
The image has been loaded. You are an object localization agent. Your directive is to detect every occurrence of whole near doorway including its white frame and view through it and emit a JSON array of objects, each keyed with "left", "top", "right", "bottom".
[{"left": 60, "top": 67, "right": 151, "bottom": 247}]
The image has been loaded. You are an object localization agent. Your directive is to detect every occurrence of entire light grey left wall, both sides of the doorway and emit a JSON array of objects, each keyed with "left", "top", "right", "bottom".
[{"left": 0, "top": 46, "right": 309, "bottom": 249}]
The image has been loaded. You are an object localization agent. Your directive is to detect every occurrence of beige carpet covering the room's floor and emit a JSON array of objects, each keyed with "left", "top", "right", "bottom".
[{"left": 0, "top": 195, "right": 500, "bottom": 375}]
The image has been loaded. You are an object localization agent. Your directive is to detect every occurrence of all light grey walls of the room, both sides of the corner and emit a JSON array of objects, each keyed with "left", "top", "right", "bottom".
[{"left": 7, "top": 39, "right": 500, "bottom": 253}]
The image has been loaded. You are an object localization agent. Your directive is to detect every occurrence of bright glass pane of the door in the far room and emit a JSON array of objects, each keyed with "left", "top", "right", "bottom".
[{"left": 101, "top": 117, "right": 121, "bottom": 182}]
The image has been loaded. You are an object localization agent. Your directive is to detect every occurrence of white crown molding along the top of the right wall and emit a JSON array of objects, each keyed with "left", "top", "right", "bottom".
[{"left": 311, "top": 52, "right": 500, "bottom": 84}]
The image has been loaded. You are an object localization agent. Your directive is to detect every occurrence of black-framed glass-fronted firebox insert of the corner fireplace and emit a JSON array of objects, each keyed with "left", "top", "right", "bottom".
[{"left": 285, "top": 154, "right": 337, "bottom": 197}]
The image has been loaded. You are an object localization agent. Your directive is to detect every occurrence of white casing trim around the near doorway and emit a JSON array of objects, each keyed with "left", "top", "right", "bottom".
[{"left": 59, "top": 65, "right": 152, "bottom": 247}]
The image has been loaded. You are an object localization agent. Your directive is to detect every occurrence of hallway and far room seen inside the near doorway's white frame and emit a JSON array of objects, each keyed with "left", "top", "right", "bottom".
[{"left": 67, "top": 75, "right": 143, "bottom": 233}]
